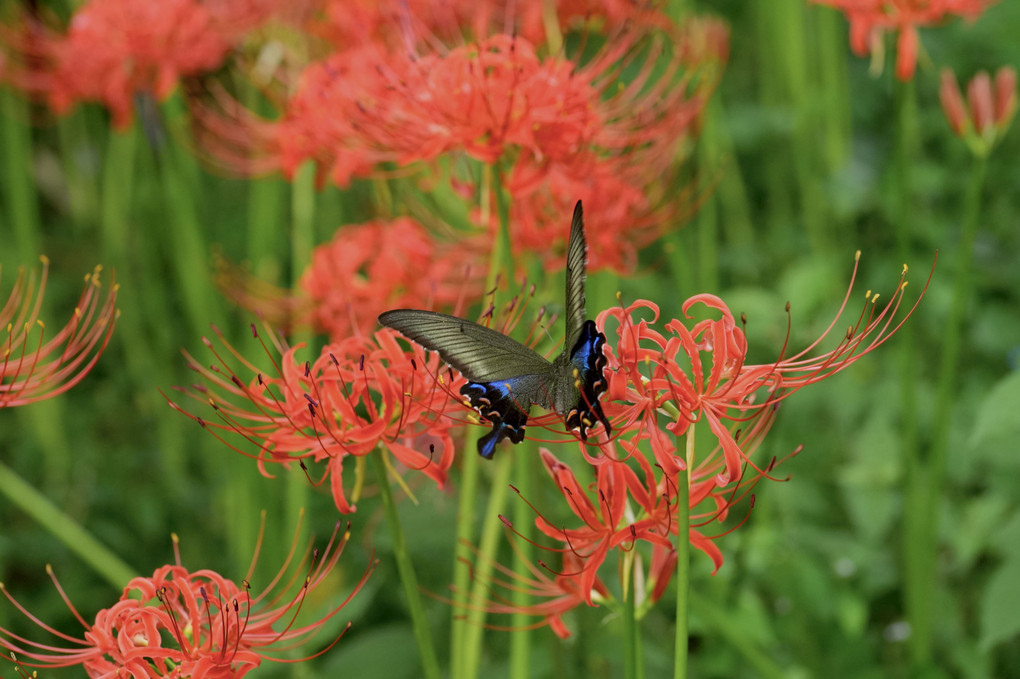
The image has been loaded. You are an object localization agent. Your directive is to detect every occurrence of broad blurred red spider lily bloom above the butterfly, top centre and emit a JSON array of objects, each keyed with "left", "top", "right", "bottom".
[{"left": 196, "top": 16, "right": 718, "bottom": 190}]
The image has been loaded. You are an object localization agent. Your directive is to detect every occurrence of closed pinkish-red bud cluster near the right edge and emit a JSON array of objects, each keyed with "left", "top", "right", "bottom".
[{"left": 938, "top": 66, "right": 1017, "bottom": 156}]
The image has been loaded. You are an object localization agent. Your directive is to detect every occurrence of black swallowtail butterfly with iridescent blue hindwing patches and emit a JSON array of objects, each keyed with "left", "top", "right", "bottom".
[{"left": 379, "top": 201, "right": 612, "bottom": 459}]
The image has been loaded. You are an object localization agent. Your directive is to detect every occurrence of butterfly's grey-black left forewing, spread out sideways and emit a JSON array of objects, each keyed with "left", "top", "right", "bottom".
[{"left": 379, "top": 309, "right": 553, "bottom": 381}]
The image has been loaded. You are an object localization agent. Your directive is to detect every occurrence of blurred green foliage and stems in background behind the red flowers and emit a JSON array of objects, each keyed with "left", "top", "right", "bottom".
[{"left": 0, "top": 0, "right": 1020, "bottom": 679}]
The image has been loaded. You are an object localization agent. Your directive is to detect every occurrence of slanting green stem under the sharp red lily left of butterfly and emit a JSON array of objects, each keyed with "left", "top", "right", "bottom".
[{"left": 368, "top": 450, "right": 442, "bottom": 679}]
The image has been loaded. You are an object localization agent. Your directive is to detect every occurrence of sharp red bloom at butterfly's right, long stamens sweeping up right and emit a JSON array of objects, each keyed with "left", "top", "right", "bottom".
[{"left": 599, "top": 248, "right": 930, "bottom": 485}]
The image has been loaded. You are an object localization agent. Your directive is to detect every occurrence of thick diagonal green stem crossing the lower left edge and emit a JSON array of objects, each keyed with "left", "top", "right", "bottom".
[{"left": 0, "top": 463, "right": 138, "bottom": 588}]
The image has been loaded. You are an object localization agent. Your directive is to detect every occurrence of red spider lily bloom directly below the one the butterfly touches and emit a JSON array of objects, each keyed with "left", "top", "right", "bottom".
[{"left": 486, "top": 438, "right": 764, "bottom": 637}]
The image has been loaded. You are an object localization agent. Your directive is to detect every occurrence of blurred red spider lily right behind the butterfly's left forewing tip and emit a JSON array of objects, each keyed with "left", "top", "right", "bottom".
[{"left": 220, "top": 217, "right": 483, "bottom": 340}]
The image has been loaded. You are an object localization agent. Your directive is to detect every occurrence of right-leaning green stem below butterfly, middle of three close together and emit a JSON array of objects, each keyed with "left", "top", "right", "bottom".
[{"left": 461, "top": 451, "right": 518, "bottom": 679}]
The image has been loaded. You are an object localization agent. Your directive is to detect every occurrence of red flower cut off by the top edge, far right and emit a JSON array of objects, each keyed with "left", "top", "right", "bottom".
[{"left": 813, "top": 0, "right": 996, "bottom": 81}]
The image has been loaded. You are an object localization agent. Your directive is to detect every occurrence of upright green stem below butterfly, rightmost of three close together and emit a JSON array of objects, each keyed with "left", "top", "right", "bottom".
[{"left": 510, "top": 440, "right": 540, "bottom": 679}]
